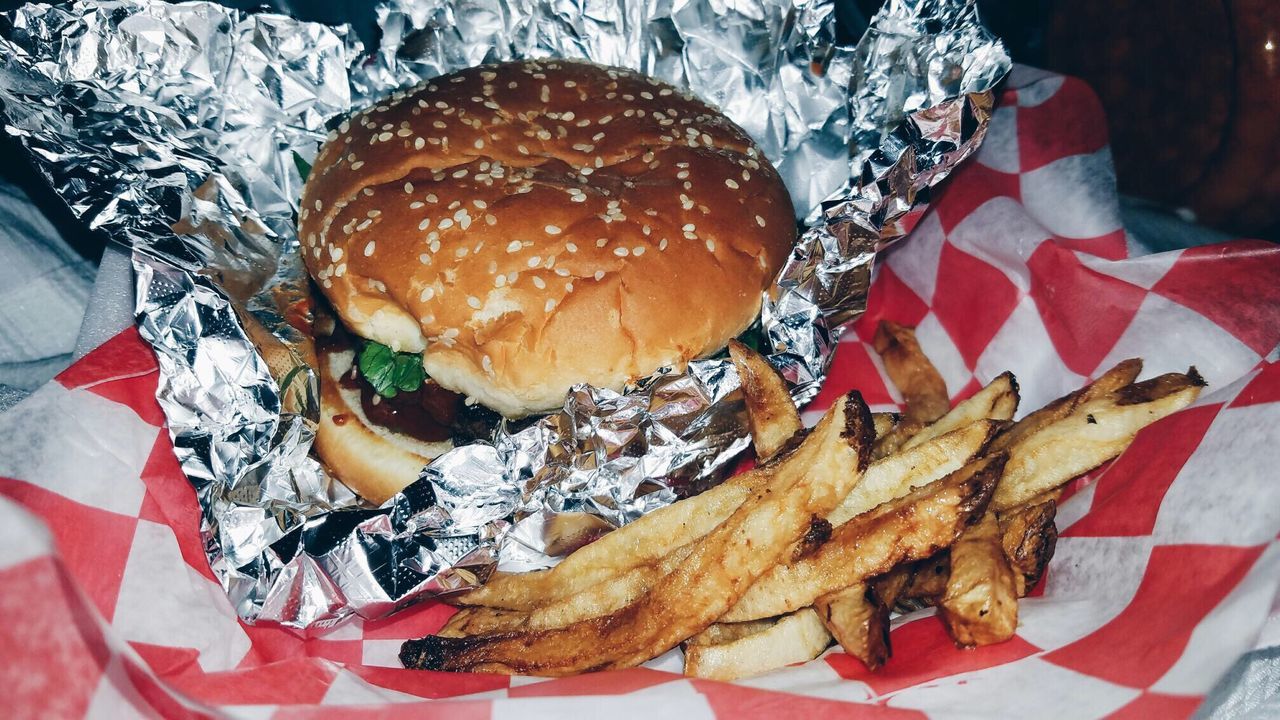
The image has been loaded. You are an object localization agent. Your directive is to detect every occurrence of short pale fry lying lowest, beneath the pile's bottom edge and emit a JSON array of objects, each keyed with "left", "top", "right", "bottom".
[{"left": 685, "top": 607, "right": 831, "bottom": 680}]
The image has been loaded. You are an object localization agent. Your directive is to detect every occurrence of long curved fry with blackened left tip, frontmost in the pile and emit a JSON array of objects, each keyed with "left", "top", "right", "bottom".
[{"left": 401, "top": 393, "right": 872, "bottom": 675}]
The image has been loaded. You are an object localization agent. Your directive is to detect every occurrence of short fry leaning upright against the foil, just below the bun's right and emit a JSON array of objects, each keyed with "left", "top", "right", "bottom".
[{"left": 728, "top": 340, "right": 804, "bottom": 460}]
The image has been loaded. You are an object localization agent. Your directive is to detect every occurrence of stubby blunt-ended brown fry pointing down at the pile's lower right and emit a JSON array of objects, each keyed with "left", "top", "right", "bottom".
[{"left": 938, "top": 511, "right": 1018, "bottom": 647}]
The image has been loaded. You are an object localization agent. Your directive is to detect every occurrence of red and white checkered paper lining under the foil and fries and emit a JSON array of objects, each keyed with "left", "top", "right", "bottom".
[{"left": 0, "top": 68, "right": 1280, "bottom": 720}]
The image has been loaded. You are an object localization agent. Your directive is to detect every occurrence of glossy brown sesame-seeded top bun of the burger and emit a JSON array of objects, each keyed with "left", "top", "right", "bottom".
[{"left": 300, "top": 61, "right": 795, "bottom": 416}]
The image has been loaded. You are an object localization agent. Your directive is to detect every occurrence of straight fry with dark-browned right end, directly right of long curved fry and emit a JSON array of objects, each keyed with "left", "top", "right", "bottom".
[{"left": 721, "top": 455, "right": 1005, "bottom": 623}]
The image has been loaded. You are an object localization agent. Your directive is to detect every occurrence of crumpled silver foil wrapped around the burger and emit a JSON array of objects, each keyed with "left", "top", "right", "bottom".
[{"left": 0, "top": 0, "right": 1009, "bottom": 629}]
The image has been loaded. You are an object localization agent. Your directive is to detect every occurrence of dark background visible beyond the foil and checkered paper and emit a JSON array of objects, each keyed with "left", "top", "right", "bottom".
[{"left": 0, "top": 0, "right": 1280, "bottom": 266}]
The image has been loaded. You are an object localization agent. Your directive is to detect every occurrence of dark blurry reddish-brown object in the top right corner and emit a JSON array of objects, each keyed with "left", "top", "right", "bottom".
[{"left": 1044, "top": 0, "right": 1280, "bottom": 237}]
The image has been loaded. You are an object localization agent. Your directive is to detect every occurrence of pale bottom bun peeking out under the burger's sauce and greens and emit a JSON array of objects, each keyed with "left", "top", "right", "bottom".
[{"left": 315, "top": 350, "right": 453, "bottom": 505}]
